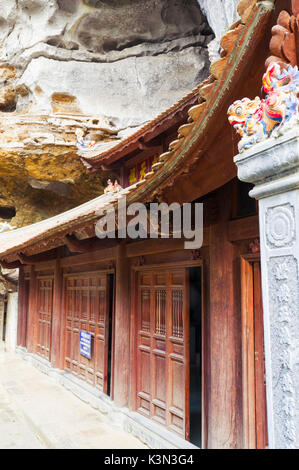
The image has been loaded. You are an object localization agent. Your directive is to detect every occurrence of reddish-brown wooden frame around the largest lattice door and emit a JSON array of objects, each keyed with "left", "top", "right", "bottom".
[{"left": 129, "top": 257, "right": 207, "bottom": 448}]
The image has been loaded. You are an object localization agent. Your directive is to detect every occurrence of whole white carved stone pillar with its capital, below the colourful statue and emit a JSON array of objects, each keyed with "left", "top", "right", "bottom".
[{"left": 235, "top": 125, "right": 299, "bottom": 448}]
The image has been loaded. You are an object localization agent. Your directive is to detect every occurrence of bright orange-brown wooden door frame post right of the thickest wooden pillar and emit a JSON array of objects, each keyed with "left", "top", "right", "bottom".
[{"left": 241, "top": 253, "right": 266, "bottom": 449}]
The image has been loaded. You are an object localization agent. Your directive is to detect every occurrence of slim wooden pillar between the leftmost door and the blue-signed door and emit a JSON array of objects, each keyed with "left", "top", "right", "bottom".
[{"left": 51, "top": 259, "right": 64, "bottom": 369}]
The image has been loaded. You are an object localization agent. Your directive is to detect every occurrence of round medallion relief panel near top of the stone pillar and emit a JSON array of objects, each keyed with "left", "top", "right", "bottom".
[{"left": 266, "top": 204, "right": 296, "bottom": 249}]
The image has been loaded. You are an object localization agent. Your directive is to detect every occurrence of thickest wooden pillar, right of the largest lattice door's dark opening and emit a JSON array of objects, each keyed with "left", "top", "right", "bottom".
[{"left": 207, "top": 185, "right": 242, "bottom": 449}]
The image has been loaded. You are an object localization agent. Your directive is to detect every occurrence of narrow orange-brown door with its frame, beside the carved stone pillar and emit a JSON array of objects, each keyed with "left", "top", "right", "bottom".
[{"left": 242, "top": 259, "right": 268, "bottom": 449}]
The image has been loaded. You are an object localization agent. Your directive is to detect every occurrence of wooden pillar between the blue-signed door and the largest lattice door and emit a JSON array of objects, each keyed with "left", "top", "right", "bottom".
[{"left": 114, "top": 243, "right": 130, "bottom": 406}]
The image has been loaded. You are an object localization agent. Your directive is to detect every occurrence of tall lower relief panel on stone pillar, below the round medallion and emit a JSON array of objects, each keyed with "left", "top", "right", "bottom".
[{"left": 268, "top": 255, "right": 299, "bottom": 448}]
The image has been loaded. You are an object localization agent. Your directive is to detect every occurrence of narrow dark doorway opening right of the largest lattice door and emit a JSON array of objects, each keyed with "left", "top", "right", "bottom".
[{"left": 189, "top": 267, "right": 202, "bottom": 447}]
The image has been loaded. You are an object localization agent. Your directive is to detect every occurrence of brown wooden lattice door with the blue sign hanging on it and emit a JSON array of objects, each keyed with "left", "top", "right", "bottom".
[{"left": 65, "top": 273, "right": 109, "bottom": 393}]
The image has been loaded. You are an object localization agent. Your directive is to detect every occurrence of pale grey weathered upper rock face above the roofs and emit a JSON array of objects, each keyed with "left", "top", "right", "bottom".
[{"left": 0, "top": 0, "right": 211, "bottom": 129}]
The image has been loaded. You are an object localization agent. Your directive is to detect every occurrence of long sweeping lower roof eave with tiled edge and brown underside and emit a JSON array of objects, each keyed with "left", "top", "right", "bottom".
[{"left": 0, "top": 0, "right": 280, "bottom": 262}]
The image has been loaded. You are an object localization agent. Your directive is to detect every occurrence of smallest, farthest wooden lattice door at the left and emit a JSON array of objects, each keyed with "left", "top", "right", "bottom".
[{"left": 37, "top": 277, "right": 53, "bottom": 360}]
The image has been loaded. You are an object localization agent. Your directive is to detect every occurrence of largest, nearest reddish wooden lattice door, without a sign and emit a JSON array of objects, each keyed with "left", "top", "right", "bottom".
[{"left": 137, "top": 269, "right": 189, "bottom": 439}]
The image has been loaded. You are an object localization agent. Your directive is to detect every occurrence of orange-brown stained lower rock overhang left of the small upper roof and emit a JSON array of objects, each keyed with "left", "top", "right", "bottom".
[{"left": 0, "top": 111, "right": 116, "bottom": 227}]
